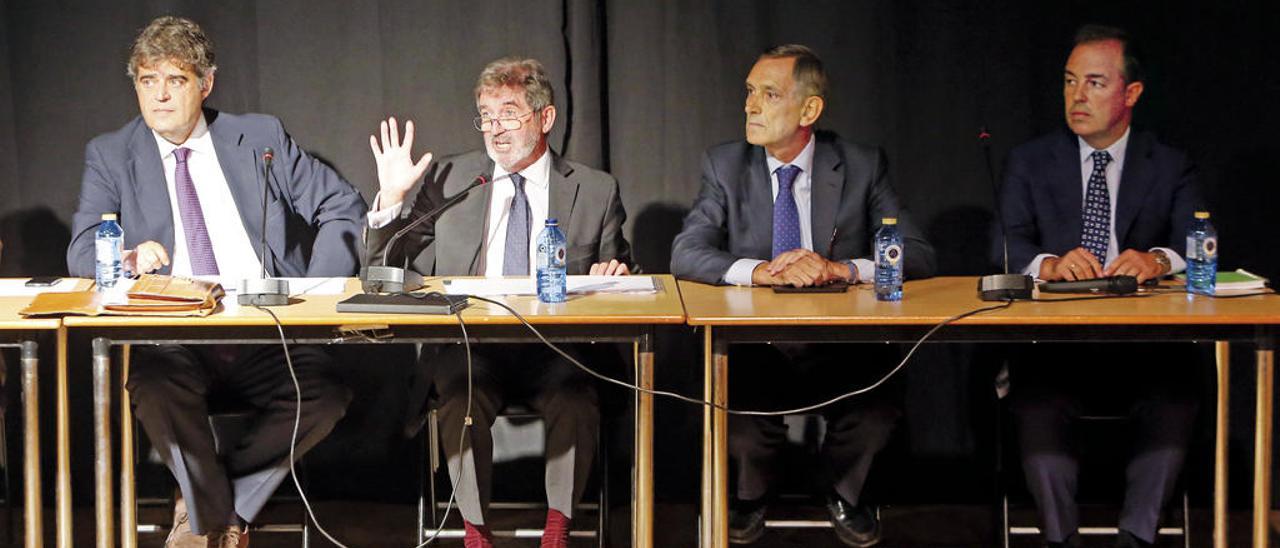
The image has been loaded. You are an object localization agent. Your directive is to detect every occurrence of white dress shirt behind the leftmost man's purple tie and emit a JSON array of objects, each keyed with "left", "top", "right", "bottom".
[{"left": 152, "top": 115, "right": 262, "bottom": 280}]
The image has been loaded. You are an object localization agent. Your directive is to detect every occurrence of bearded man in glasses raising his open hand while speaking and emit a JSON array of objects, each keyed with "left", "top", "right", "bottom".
[{"left": 367, "top": 58, "right": 631, "bottom": 548}]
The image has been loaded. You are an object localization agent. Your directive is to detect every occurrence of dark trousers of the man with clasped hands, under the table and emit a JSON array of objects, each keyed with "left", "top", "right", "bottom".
[{"left": 728, "top": 344, "right": 902, "bottom": 504}]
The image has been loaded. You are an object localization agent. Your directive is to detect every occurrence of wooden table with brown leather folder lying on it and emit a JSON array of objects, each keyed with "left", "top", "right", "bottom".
[{"left": 64, "top": 275, "right": 685, "bottom": 547}]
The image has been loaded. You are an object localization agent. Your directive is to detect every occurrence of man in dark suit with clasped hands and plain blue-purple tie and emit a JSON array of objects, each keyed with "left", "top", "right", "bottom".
[{"left": 671, "top": 45, "right": 934, "bottom": 547}]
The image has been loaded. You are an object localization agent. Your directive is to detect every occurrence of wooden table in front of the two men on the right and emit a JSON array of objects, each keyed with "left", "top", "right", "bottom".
[{"left": 680, "top": 278, "right": 1280, "bottom": 547}]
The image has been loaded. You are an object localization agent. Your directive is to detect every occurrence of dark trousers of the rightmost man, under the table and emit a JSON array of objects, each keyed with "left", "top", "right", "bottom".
[{"left": 1010, "top": 344, "right": 1201, "bottom": 542}]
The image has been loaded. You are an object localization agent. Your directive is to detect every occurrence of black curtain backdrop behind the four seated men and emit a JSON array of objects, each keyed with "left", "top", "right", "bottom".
[{"left": 0, "top": 0, "right": 1280, "bottom": 522}]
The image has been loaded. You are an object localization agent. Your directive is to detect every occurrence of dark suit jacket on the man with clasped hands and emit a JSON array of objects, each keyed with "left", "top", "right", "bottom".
[{"left": 671, "top": 132, "right": 937, "bottom": 283}]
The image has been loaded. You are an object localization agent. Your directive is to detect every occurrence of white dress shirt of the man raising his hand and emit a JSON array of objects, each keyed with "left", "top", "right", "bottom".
[{"left": 369, "top": 149, "right": 563, "bottom": 278}]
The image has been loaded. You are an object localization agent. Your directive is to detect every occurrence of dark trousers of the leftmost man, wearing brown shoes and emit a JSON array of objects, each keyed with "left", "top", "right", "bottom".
[{"left": 125, "top": 344, "right": 351, "bottom": 534}]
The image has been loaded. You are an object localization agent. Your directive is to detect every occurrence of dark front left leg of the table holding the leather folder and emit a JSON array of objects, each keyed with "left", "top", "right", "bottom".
[{"left": 93, "top": 337, "right": 115, "bottom": 548}]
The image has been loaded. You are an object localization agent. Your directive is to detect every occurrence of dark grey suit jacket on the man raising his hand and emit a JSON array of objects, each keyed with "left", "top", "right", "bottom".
[{"left": 366, "top": 151, "right": 631, "bottom": 275}]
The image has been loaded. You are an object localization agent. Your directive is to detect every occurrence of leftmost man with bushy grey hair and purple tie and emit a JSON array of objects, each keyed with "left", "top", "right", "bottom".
[{"left": 67, "top": 17, "right": 365, "bottom": 547}]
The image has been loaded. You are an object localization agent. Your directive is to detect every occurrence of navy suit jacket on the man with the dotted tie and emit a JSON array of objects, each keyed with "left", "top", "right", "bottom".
[{"left": 993, "top": 129, "right": 1203, "bottom": 271}]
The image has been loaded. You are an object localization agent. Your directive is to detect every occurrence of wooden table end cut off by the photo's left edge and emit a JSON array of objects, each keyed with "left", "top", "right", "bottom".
[{"left": 0, "top": 297, "right": 70, "bottom": 547}]
